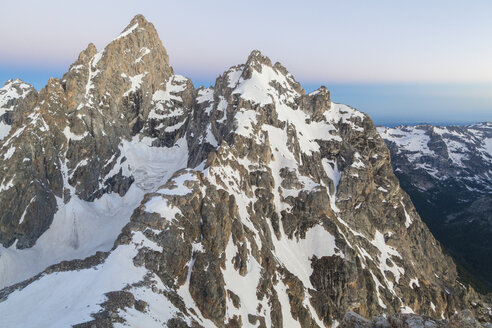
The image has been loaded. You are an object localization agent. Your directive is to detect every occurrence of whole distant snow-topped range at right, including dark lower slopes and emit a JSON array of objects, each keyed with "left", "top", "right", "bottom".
[{"left": 378, "top": 122, "right": 492, "bottom": 290}]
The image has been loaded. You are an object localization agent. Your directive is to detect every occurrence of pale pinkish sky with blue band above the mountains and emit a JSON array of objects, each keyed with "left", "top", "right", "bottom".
[{"left": 0, "top": 0, "right": 492, "bottom": 125}]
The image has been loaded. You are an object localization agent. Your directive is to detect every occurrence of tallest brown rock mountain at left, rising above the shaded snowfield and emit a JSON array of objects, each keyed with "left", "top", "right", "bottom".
[{"left": 0, "top": 16, "right": 195, "bottom": 254}]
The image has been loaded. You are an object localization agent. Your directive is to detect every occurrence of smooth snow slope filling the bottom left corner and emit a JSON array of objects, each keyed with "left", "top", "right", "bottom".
[{"left": 0, "top": 233, "right": 154, "bottom": 328}]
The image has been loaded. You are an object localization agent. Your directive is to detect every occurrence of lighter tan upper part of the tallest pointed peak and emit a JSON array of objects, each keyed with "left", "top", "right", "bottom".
[{"left": 63, "top": 15, "right": 173, "bottom": 114}]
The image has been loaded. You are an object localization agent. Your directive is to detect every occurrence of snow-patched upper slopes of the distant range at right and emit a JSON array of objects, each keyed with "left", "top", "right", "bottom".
[{"left": 378, "top": 122, "right": 492, "bottom": 195}]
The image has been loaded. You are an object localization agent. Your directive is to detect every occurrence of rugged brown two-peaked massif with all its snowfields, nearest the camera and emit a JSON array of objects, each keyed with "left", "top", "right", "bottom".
[{"left": 0, "top": 15, "right": 492, "bottom": 327}]
